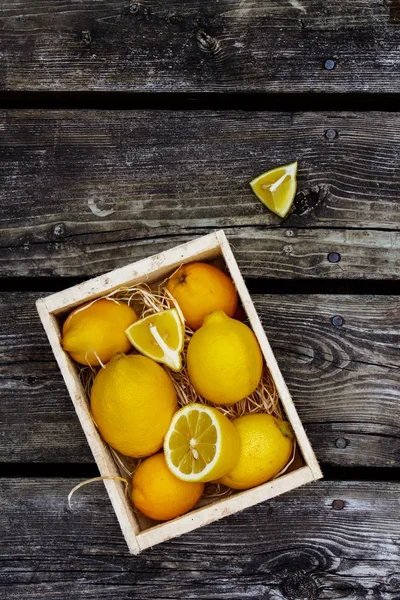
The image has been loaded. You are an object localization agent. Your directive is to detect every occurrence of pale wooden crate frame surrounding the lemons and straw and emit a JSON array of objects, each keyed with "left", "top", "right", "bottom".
[{"left": 36, "top": 231, "right": 322, "bottom": 554}]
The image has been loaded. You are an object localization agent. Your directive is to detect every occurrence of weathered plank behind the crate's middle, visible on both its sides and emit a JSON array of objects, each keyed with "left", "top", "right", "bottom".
[{"left": 0, "top": 293, "right": 400, "bottom": 467}]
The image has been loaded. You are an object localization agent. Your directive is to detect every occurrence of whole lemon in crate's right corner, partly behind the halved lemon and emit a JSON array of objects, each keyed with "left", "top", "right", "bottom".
[{"left": 218, "top": 414, "right": 294, "bottom": 490}]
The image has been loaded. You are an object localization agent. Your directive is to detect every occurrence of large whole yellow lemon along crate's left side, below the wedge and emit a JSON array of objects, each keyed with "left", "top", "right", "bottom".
[{"left": 90, "top": 354, "right": 178, "bottom": 458}]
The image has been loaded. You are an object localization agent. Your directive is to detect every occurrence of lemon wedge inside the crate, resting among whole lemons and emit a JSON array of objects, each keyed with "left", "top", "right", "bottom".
[{"left": 125, "top": 308, "right": 185, "bottom": 371}]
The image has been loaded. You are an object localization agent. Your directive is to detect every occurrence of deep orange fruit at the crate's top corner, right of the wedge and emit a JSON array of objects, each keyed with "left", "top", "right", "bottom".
[{"left": 167, "top": 262, "right": 238, "bottom": 330}]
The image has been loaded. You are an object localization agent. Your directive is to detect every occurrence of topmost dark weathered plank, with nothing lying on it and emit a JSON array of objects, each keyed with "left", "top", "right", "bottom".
[{"left": 0, "top": 0, "right": 400, "bottom": 92}]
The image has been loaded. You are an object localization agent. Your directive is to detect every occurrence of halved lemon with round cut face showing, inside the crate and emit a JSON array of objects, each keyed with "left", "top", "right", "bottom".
[{"left": 164, "top": 403, "right": 240, "bottom": 482}]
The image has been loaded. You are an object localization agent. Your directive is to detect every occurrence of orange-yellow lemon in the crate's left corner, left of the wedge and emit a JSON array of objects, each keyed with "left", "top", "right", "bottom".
[{"left": 61, "top": 298, "right": 137, "bottom": 366}]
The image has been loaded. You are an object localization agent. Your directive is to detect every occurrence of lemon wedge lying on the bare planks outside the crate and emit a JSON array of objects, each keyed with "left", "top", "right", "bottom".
[{"left": 250, "top": 161, "right": 297, "bottom": 217}]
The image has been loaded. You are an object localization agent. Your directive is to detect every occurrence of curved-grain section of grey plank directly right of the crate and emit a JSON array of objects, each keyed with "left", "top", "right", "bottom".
[{"left": 256, "top": 295, "right": 400, "bottom": 466}]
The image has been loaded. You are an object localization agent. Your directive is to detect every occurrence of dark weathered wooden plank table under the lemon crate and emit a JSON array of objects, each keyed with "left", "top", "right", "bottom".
[{"left": 0, "top": 0, "right": 400, "bottom": 600}]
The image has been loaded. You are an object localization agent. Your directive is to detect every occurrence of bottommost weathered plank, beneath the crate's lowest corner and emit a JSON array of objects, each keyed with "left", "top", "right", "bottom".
[{"left": 0, "top": 478, "right": 400, "bottom": 600}]
